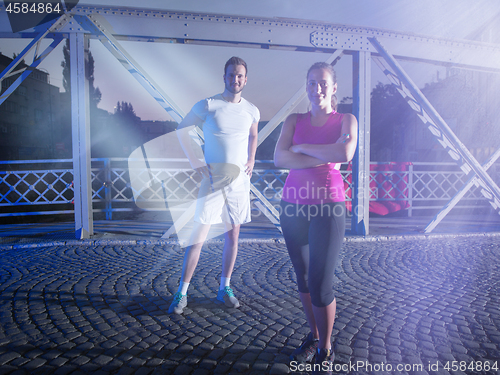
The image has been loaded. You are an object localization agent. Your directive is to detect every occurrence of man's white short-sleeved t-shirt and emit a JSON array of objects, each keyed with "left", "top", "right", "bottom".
[{"left": 192, "top": 94, "right": 260, "bottom": 172}]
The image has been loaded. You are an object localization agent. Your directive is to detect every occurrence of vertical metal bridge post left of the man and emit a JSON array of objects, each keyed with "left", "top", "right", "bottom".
[{"left": 69, "top": 32, "right": 94, "bottom": 239}]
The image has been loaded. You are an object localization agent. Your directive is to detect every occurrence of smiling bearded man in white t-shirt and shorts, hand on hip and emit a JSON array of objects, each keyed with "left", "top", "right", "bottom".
[{"left": 168, "top": 57, "right": 260, "bottom": 314}]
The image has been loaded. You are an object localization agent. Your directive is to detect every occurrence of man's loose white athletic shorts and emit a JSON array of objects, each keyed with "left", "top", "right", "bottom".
[{"left": 194, "top": 173, "right": 251, "bottom": 225}]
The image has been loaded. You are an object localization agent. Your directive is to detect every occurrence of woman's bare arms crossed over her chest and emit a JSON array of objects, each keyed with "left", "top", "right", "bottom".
[{"left": 274, "top": 113, "right": 358, "bottom": 169}]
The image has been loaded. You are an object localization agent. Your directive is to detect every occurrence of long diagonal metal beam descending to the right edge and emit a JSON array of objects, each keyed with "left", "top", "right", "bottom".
[{"left": 368, "top": 37, "right": 500, "bottom": 207}]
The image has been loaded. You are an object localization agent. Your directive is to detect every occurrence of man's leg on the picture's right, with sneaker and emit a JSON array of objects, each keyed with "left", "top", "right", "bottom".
[{"left": 217, "top": 223, "right": 240, "bottom": 308}]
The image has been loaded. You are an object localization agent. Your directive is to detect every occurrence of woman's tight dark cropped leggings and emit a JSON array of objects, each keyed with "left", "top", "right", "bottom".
[{"left": 280, "top": 201, "right": 345, "bottom": 307}]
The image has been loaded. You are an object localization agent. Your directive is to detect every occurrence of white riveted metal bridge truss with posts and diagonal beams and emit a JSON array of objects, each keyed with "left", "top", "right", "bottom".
[{"left": 0, "top": 6, "right": 500, "bottom": 238}]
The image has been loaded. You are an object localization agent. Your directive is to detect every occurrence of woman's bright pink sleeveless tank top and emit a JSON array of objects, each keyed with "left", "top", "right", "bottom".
[{"left": 282, "top": 112, "right": 345, "bottom": 204}]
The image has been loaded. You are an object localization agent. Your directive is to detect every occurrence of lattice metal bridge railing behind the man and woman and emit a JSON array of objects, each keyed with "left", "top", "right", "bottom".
[{"left": 0, "top": 158, "right": 500, "bottom": 220}]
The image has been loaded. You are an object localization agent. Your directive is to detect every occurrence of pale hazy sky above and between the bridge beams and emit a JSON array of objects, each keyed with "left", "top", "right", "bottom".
[{"left": 0, "top": 0, "right": 500, "bottom": 121}]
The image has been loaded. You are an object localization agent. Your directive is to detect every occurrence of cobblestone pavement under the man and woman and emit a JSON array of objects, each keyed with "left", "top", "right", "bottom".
[{"left": 0, "top": 236, "right": 500, "bottom": 375}]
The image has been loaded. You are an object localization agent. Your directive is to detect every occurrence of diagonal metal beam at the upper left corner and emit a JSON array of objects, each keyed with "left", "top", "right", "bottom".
[{"left": 0, "top": 14, "right": 72, "bottom": 105}]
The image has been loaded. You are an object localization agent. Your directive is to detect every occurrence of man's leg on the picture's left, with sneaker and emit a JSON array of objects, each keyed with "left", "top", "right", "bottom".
[{"left": 168, "top": 222, "right": 210, "bottom": 314}]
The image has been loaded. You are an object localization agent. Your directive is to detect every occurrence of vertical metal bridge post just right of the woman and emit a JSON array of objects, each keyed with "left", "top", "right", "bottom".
[{"left": 351, "top": 51, "right": 371, "bottom": 236}]
